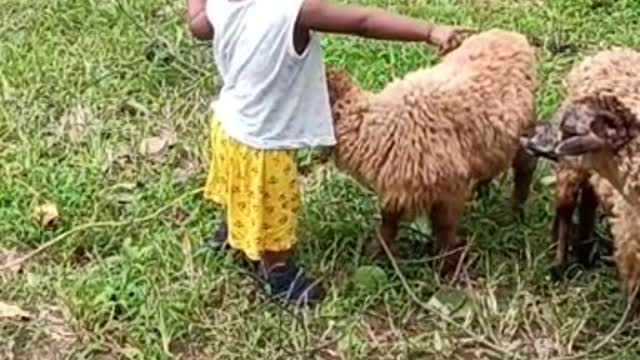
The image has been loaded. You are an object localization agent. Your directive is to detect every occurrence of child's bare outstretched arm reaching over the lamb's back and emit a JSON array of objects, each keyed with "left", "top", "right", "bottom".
[{"left": 298, "top": 0, "right": 468, "bottom": 52}]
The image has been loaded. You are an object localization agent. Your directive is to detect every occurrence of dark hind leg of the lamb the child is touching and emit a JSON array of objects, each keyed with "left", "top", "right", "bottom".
[{"left": 511, "top": 148, "right": 538, "bottom": 220}]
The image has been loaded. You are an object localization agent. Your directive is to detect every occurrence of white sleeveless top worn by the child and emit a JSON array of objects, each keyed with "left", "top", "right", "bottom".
[{"left": 207, "top": 0, "right": 335, "bottom": 149}]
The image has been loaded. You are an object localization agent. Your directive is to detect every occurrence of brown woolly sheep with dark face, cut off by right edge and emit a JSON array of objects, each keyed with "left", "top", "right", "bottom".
[{"left": 521, "top": 49, "right": 640, "bottom": 315}]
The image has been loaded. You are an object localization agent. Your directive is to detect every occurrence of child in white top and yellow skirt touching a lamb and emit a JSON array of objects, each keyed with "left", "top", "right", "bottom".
[{"left": 187, "top": 0, "right": 466, "bottom": 304}]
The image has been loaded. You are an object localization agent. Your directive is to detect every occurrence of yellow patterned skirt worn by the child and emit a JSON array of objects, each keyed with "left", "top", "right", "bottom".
[{"left": 204, "top": 117, "right": 300, "bottom": 261}]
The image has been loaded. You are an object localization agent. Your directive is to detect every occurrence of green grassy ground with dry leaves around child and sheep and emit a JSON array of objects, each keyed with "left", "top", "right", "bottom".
[{"left": 0, "top": 0, "right": 640, "bottom": 359}]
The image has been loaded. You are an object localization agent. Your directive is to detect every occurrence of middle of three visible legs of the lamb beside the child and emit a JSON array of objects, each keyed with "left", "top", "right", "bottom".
[{"left": 430, "top": 197, "right": 465, "bottom": 277}]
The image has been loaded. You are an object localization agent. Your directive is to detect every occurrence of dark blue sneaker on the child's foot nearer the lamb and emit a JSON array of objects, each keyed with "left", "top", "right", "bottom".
[{"left": 260, "top": 261, "right": 325, "bottom": 306}]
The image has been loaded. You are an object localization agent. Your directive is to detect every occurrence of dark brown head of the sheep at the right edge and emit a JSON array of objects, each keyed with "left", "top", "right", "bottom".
[{"left": 520, "top": 96, "right": 640, "bottom": 160}]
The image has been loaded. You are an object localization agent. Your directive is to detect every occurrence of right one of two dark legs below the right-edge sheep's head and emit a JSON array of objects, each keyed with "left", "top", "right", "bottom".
[{"left": 572, "top": 186, "right": 598, "bottom": 267}]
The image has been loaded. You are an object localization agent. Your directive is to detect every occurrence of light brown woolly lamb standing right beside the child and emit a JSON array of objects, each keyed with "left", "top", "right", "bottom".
[{"left": 327, "top": 30, "right": 536, "bottom": 275}]
